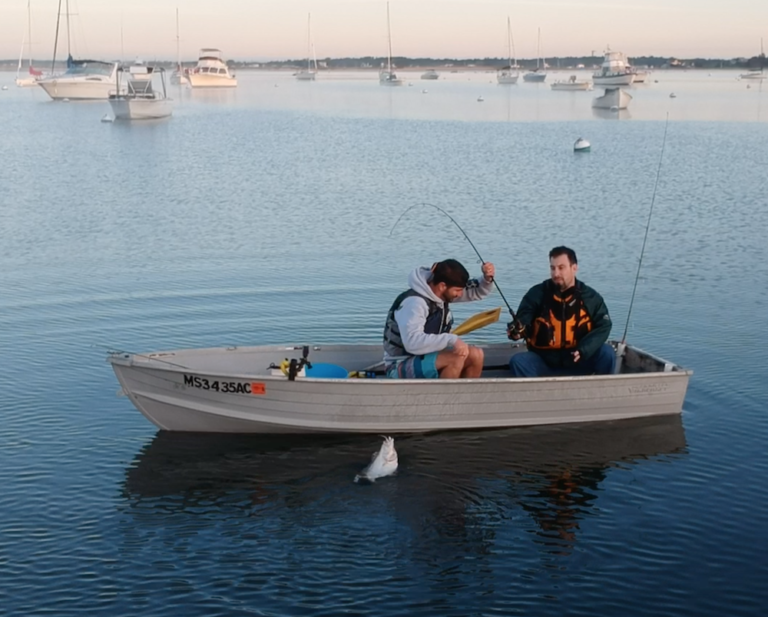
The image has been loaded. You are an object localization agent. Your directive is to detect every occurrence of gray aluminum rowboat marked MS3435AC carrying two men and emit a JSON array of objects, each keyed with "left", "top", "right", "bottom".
[{"left": 107, "top": 343, "right": 692, "bottom": 434}]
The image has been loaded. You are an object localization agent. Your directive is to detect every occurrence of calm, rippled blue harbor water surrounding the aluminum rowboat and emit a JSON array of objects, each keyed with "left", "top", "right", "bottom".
[{"left": 0, "top": 72, "right": 768, "bottom": 617}]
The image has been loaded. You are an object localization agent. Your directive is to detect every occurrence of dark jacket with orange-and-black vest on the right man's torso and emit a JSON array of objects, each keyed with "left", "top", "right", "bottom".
[{"left": 517, "top": 279, "right": 613, "bottom": 368}]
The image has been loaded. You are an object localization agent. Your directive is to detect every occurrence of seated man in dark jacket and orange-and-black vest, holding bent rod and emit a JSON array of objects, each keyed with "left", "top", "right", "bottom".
[{"left": 507, "top": 246, "right": 616, "bottom": 377}]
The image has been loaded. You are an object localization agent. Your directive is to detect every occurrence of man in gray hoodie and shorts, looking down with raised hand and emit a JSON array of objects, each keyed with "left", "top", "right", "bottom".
[{"left": 384, "top": 259, "right": 495, "bottom": 379}]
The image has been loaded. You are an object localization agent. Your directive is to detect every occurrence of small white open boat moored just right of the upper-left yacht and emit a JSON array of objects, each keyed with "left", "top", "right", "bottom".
[{"left": 109, "top": 62, "right": 173, "bottom": 120}]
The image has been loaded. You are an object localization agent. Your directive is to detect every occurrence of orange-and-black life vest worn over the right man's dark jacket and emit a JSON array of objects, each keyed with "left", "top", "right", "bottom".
[{"left": 526, "top": 285, "right": 593, "bottom": 350}]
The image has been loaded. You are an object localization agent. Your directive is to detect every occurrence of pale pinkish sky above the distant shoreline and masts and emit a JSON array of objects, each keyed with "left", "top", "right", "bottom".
[{"left": 0, "top": 0, "right": 768, "bottom": 61}]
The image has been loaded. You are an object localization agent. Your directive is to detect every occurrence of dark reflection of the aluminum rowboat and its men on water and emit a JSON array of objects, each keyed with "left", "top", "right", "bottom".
[{"left": 124, "top": 415, "right": 686, "bottom": 554}]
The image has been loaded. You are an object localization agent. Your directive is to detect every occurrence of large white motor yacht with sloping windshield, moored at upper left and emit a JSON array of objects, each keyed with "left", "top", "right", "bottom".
[{"left": 37, "top": 56, "right": 123, "bottom": 101}]
